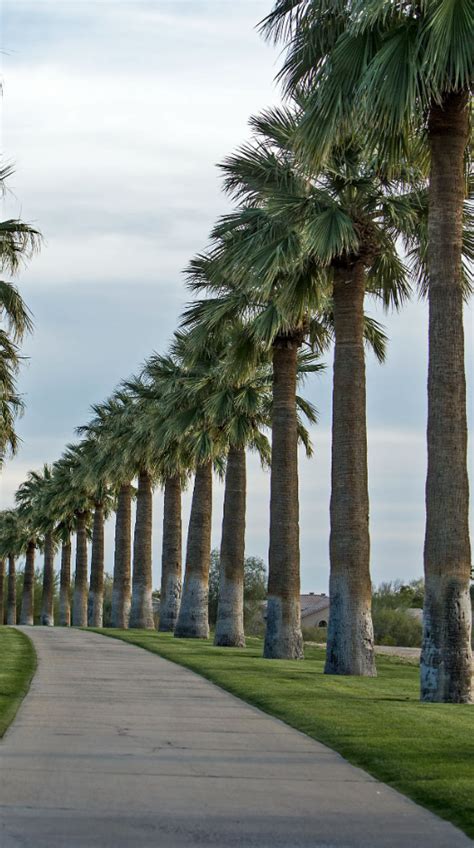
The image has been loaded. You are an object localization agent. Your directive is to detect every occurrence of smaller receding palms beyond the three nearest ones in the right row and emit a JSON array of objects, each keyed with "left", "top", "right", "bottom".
[{"left": 0, "top": 334, "right": 316, "bottom": 645}]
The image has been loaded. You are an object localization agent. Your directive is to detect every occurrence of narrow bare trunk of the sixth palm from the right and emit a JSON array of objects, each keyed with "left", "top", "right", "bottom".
[{"left": 158, "top": 474, "right": 182, "bottom": 632}]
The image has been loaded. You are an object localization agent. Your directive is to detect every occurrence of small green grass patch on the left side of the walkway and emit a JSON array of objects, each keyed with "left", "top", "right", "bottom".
[{"left": 0, "top": 627, "right": 36, "bottom": 739}]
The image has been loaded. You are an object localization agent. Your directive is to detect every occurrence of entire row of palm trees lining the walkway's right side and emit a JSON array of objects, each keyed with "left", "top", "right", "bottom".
[{"left": 0, "top": 0, "right": 473, "bottom": 702}]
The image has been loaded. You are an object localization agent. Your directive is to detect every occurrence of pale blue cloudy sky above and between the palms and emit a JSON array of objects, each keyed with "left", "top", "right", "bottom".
[{"left": 0, "top": 0, "right": 473, "bottom": 592}]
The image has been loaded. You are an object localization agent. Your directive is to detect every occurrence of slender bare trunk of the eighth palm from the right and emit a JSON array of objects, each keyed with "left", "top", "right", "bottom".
[{"left": 112, "top": 483, "right": 132, "bottom": 629}]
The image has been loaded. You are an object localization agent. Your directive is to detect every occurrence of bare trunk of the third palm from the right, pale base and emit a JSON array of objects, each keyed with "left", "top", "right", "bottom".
[{"left": 263, "top": 337, "right": 303, "bottom": 659}]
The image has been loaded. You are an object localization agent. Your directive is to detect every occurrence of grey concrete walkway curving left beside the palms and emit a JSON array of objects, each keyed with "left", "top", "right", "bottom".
[{"left": 0, "top": 627, "right": 473, "bottom": 848}]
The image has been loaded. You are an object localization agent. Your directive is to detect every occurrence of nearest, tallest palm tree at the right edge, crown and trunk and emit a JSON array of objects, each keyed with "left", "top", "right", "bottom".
[{"left": 264, "top": 0, "right": 473, "bottom": 702}]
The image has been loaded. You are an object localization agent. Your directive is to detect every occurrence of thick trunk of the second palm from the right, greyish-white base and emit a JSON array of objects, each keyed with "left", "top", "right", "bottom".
[{"left": 324, "top": 262, "right": 376, "bottom": 677}]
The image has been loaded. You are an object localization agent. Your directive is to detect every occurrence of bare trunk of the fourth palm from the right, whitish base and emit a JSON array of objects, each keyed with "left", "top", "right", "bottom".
[{"left": 214, "top": 447, "right": 246, "bottom": 648}]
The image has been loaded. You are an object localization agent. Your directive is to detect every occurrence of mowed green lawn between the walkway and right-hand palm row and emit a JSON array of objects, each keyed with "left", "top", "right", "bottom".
[{"left": 97, "top": 629, "right": 474, "bottom": 837}]
